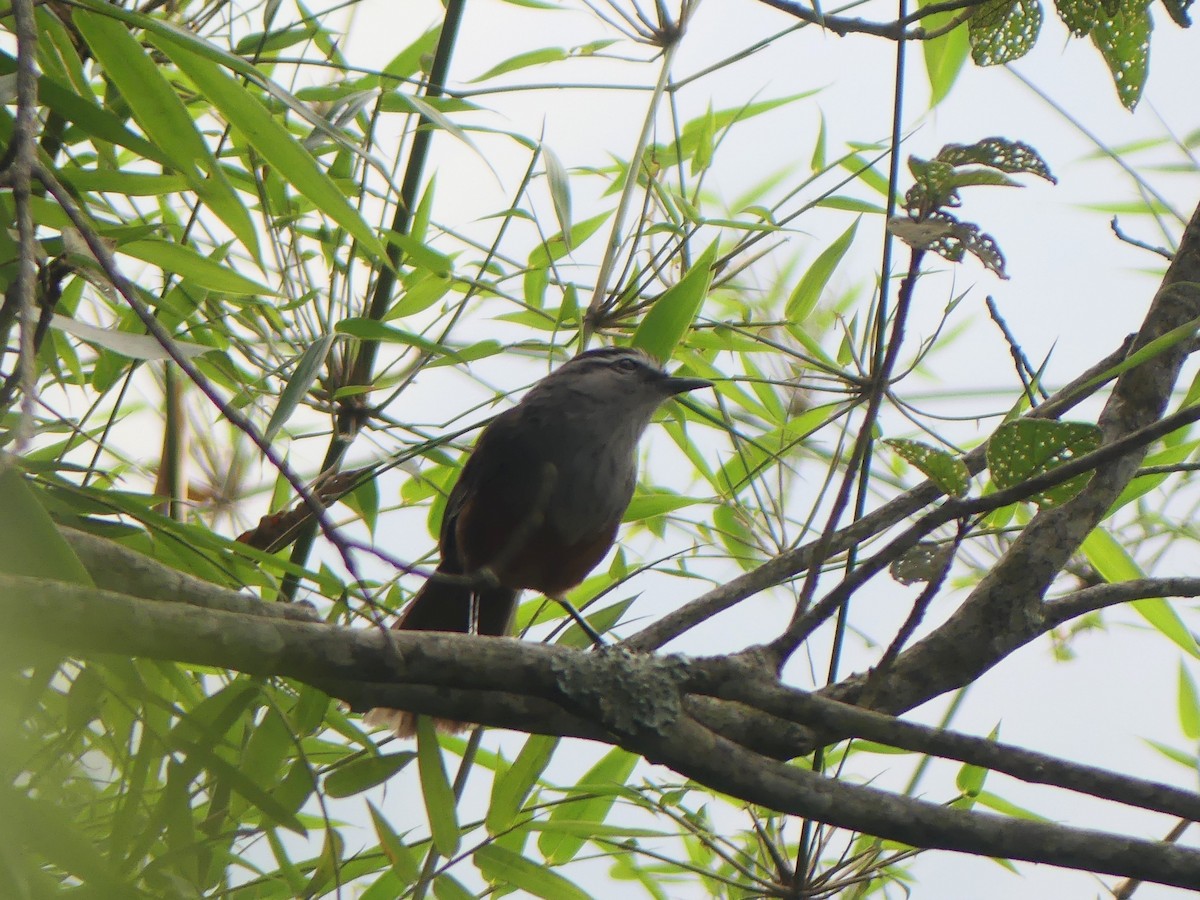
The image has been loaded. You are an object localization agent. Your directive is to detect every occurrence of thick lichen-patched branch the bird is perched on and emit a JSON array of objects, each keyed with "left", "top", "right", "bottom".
[{"left": 14, "top": 576, "right": 1200, "bottom": 887}]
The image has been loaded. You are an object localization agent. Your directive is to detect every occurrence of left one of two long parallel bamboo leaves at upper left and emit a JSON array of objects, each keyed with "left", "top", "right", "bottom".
[{"left": 72, "top": 10, "right": 260, "bottom": 259}]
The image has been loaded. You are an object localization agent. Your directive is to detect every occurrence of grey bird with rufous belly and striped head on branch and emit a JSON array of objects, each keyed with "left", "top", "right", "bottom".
[{"left": 365, "top": 347, "right": 712, "bottom": 737}]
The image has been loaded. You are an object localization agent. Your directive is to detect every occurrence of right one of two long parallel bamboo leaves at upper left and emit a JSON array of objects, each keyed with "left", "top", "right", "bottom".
[{"left": 152, "top": 34, "right": 386, "bottom": 259}]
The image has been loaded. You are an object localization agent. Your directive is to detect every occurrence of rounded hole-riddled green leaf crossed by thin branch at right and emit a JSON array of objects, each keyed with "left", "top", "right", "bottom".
[{"left": 988, "top": 419, "right": 1100, "bottom": 506}]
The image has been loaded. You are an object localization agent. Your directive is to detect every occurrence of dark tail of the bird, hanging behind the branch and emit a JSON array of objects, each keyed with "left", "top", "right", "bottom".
[{"left": 362, "top": 577, "right": 518, "bottom": 738}]
